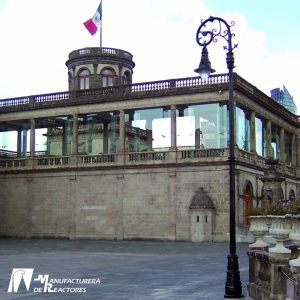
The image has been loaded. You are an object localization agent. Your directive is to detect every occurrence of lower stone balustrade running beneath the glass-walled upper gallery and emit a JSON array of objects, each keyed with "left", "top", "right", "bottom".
[{"left": 0, "top": 148, "right": 296, "bottom": 175}]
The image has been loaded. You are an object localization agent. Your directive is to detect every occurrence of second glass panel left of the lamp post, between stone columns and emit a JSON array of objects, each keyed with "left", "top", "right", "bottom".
[{"left": 125, "top": 108, "right": 171, "bottom": 152}]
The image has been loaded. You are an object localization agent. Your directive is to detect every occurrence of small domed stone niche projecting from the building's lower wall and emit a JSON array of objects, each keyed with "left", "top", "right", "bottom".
[{"left": 189, "top": 188, "right": 214, "bottom": 242}]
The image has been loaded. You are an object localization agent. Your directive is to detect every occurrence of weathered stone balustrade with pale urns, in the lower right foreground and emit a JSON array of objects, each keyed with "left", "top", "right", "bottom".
[{"left": 248, "top": 215, "right": 300, "bottom": 300}]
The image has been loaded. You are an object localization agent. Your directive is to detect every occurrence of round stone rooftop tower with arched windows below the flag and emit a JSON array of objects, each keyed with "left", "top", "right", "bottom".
[{"left": 66, "top": 47, "right": 135, "bottom": 91}]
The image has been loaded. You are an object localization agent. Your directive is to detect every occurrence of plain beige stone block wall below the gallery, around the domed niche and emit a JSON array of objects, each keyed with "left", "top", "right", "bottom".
[{"left": 0, "top": 166, "right": 229, "bottom": 241}]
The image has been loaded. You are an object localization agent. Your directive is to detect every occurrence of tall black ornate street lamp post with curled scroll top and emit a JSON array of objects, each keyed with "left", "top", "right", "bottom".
[{"left": 195, "top": 17, "right": 243, "bottom": 298}]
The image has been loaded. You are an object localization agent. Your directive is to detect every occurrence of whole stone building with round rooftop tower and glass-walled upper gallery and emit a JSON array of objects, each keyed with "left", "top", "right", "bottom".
[{"left": 0, "top": 48, "right": 300, "bottom": 241}]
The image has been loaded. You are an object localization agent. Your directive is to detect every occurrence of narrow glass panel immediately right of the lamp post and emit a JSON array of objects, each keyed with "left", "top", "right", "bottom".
[{"left": 236, "top": 107, "right": 250, "bottom": 151}]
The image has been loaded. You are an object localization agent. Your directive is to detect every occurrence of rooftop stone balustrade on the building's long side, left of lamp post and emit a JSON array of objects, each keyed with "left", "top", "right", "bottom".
[{"left": 0, "top": 74, "right": 228, "bottom": 112}]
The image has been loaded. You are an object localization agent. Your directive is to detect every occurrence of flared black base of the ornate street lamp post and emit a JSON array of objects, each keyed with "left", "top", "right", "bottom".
[{"left": 224, "top": 254, "right": 243, "bottom": 299}]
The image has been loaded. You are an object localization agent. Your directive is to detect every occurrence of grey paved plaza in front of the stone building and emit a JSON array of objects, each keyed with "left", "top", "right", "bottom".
[{"left": 0, "top": 239, "right": 248, "bottom": 300}]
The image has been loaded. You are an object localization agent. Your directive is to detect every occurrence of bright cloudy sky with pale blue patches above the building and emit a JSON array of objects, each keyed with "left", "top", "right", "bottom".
[{"left": 0, "top": 0, "right": 300, "bottom": 113}]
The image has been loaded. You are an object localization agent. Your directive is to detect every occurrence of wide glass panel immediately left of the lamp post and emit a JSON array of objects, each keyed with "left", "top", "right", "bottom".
[{"left": 177, "top": 103, "right": 228, "bottom": 149}]
